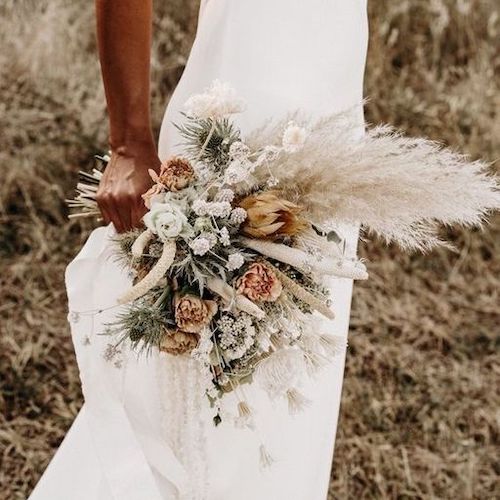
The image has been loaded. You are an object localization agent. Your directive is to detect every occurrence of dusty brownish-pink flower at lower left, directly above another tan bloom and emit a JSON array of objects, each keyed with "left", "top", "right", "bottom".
[{"left": 174, "top": 294, "right": 217, "bottom": 333}]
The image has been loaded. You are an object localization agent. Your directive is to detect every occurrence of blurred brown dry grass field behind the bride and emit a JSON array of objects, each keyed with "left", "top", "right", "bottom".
[{"left": 0, "top": 0, "right": 500, "bottom": 500}]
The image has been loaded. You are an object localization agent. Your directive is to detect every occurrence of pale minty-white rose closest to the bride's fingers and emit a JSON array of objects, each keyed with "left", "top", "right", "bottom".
[{"left": 143, "top": 203, "right": 191, "bottom": 241}]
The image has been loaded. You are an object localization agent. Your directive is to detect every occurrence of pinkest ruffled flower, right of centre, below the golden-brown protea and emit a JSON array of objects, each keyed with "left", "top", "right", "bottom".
[{"left": 236, "top": 262, "right": 283, "bottom": 302}]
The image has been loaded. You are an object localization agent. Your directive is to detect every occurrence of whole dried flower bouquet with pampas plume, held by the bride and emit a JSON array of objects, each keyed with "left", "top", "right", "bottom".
[{"left": 71, "top": 81, "right": 500, "bottom": 423}]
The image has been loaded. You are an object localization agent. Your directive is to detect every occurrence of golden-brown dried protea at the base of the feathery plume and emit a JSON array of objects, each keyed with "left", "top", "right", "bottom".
[{"left": 238, "top": 191, "right": 307, "bottom": 239}]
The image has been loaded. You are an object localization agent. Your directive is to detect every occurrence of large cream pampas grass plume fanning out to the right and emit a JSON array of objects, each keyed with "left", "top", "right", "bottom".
[{"left": 247, "top": 112, "right": 500, "bottom": 251}]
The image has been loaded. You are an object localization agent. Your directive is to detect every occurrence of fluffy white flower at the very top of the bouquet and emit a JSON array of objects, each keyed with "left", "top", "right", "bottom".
[{"left": 184, "top": 80, "right": 245, "bottom": 119}]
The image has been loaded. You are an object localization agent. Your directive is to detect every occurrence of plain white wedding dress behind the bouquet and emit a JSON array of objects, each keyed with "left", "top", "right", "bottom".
[{"left": 30, "top": 0, "right": 367, "bottom": 500}]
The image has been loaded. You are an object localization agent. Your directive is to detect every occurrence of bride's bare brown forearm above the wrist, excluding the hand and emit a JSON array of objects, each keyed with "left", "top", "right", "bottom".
[{"left": 96, "top": 0, "right": 154, "bottom": 154}]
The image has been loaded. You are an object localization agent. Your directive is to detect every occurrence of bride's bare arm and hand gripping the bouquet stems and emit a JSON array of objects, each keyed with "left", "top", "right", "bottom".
[{"left": 96, "top": 0, "right": 160, "bottom": 232}]
